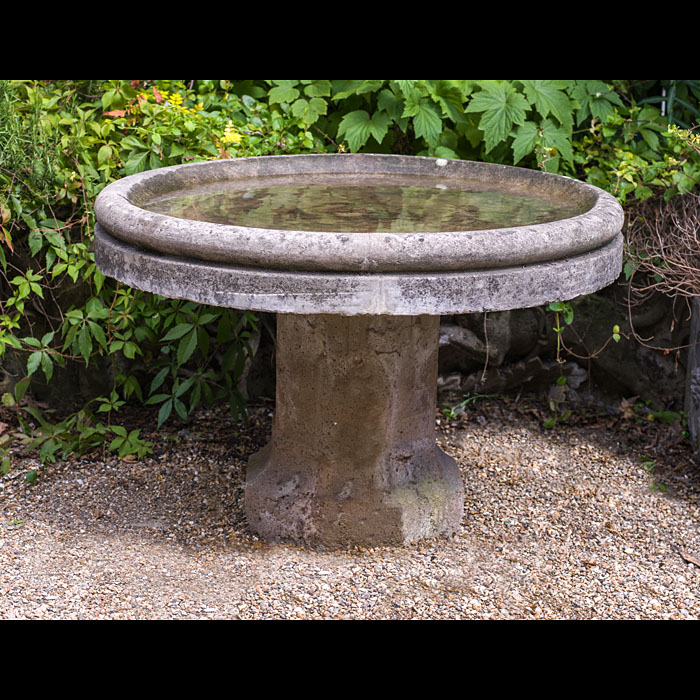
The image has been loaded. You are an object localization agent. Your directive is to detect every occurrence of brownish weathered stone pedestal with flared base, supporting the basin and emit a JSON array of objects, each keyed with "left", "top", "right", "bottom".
[{"left": 246, "top": 315, "right": 464, "bottom": 548}]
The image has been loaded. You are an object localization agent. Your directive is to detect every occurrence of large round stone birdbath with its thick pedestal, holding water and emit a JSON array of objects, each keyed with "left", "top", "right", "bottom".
[{"left": 95, "top": 154, "right": 623, "bottom": 548}]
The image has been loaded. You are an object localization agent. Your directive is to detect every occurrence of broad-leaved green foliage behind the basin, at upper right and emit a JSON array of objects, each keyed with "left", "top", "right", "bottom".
[{"left": 247, "top": 80, "right": 700, "bottom": 197}]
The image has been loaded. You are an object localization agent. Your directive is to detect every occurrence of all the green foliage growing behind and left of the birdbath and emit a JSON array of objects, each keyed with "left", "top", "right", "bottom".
[{"left": 0, "top": 80, "right": 700, "bottom": 472}]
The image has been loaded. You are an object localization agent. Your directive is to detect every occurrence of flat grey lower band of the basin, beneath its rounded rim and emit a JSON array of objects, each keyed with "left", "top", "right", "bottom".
[{"left": 95, "top": 224, "right": 622, "bottom": 316}]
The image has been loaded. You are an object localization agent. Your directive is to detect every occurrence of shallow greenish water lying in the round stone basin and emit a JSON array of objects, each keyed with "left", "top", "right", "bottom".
[{"left": 141, "top": 175, "right": 589, "bottom": 233}]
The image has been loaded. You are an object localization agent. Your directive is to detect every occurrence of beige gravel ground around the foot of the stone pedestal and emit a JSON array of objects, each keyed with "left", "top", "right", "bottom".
[{"left": 0, "top": 399, "right": 700, "bottom": 619}]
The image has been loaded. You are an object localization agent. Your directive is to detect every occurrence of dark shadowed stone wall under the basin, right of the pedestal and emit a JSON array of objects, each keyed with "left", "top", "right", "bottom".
[{"left": 440, "top": 279, "right": 688, "bottom": 411}]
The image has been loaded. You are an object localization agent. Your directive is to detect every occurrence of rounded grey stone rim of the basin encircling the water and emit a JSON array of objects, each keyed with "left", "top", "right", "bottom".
[{"left": 95, "top": 154, "right": 624, "bottom": 273}]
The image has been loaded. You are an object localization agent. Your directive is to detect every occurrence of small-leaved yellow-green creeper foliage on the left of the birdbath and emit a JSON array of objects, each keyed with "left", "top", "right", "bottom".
[{"left": 0, "top": 80, "right": 320, "bottom": 472}]
